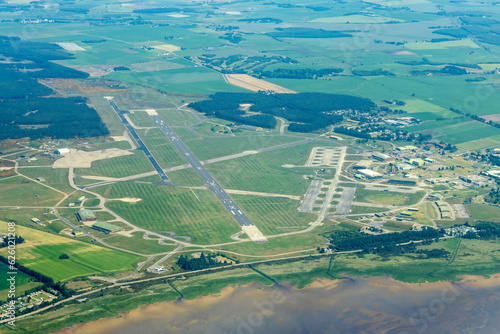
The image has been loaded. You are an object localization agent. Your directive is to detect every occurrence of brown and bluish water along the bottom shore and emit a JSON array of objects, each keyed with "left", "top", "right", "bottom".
[{"left": 57, "top": 275, "right": 500, "bottom": 334}]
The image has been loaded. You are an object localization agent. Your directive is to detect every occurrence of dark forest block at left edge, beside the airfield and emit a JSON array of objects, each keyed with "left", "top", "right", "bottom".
[{"left": 0, "top": 36, "right": 109, "bottom": 140}]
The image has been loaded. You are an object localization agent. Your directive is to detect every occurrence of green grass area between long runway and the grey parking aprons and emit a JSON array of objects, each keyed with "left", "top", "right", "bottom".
[{"left": 206, "top": 143, "right": 321, "bottom": 196}]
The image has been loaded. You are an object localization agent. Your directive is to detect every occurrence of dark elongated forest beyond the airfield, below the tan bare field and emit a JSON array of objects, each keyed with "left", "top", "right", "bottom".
[{"left": 189, "top": 92, "right": 375, "bottom": 132}]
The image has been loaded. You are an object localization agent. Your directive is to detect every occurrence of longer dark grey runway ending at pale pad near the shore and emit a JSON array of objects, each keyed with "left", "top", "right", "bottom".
[{"left": 150, "top": 115, "right": 255, "bottom": 230}]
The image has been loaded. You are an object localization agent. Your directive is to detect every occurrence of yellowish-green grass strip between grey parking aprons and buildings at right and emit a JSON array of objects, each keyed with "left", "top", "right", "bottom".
[{"left": 355, "top": 189, "right": 425, "bottom": 205}]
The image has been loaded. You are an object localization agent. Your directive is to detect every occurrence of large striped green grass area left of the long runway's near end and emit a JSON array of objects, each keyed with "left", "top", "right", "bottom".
[{"left": 94, "top": 183, "right": 240, "bottom": 244}]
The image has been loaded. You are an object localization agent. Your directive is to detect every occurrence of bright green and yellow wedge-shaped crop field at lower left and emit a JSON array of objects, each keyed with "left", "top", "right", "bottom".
[{"left": 0, "top": 223, "right": 142, "bottom": 281}]
